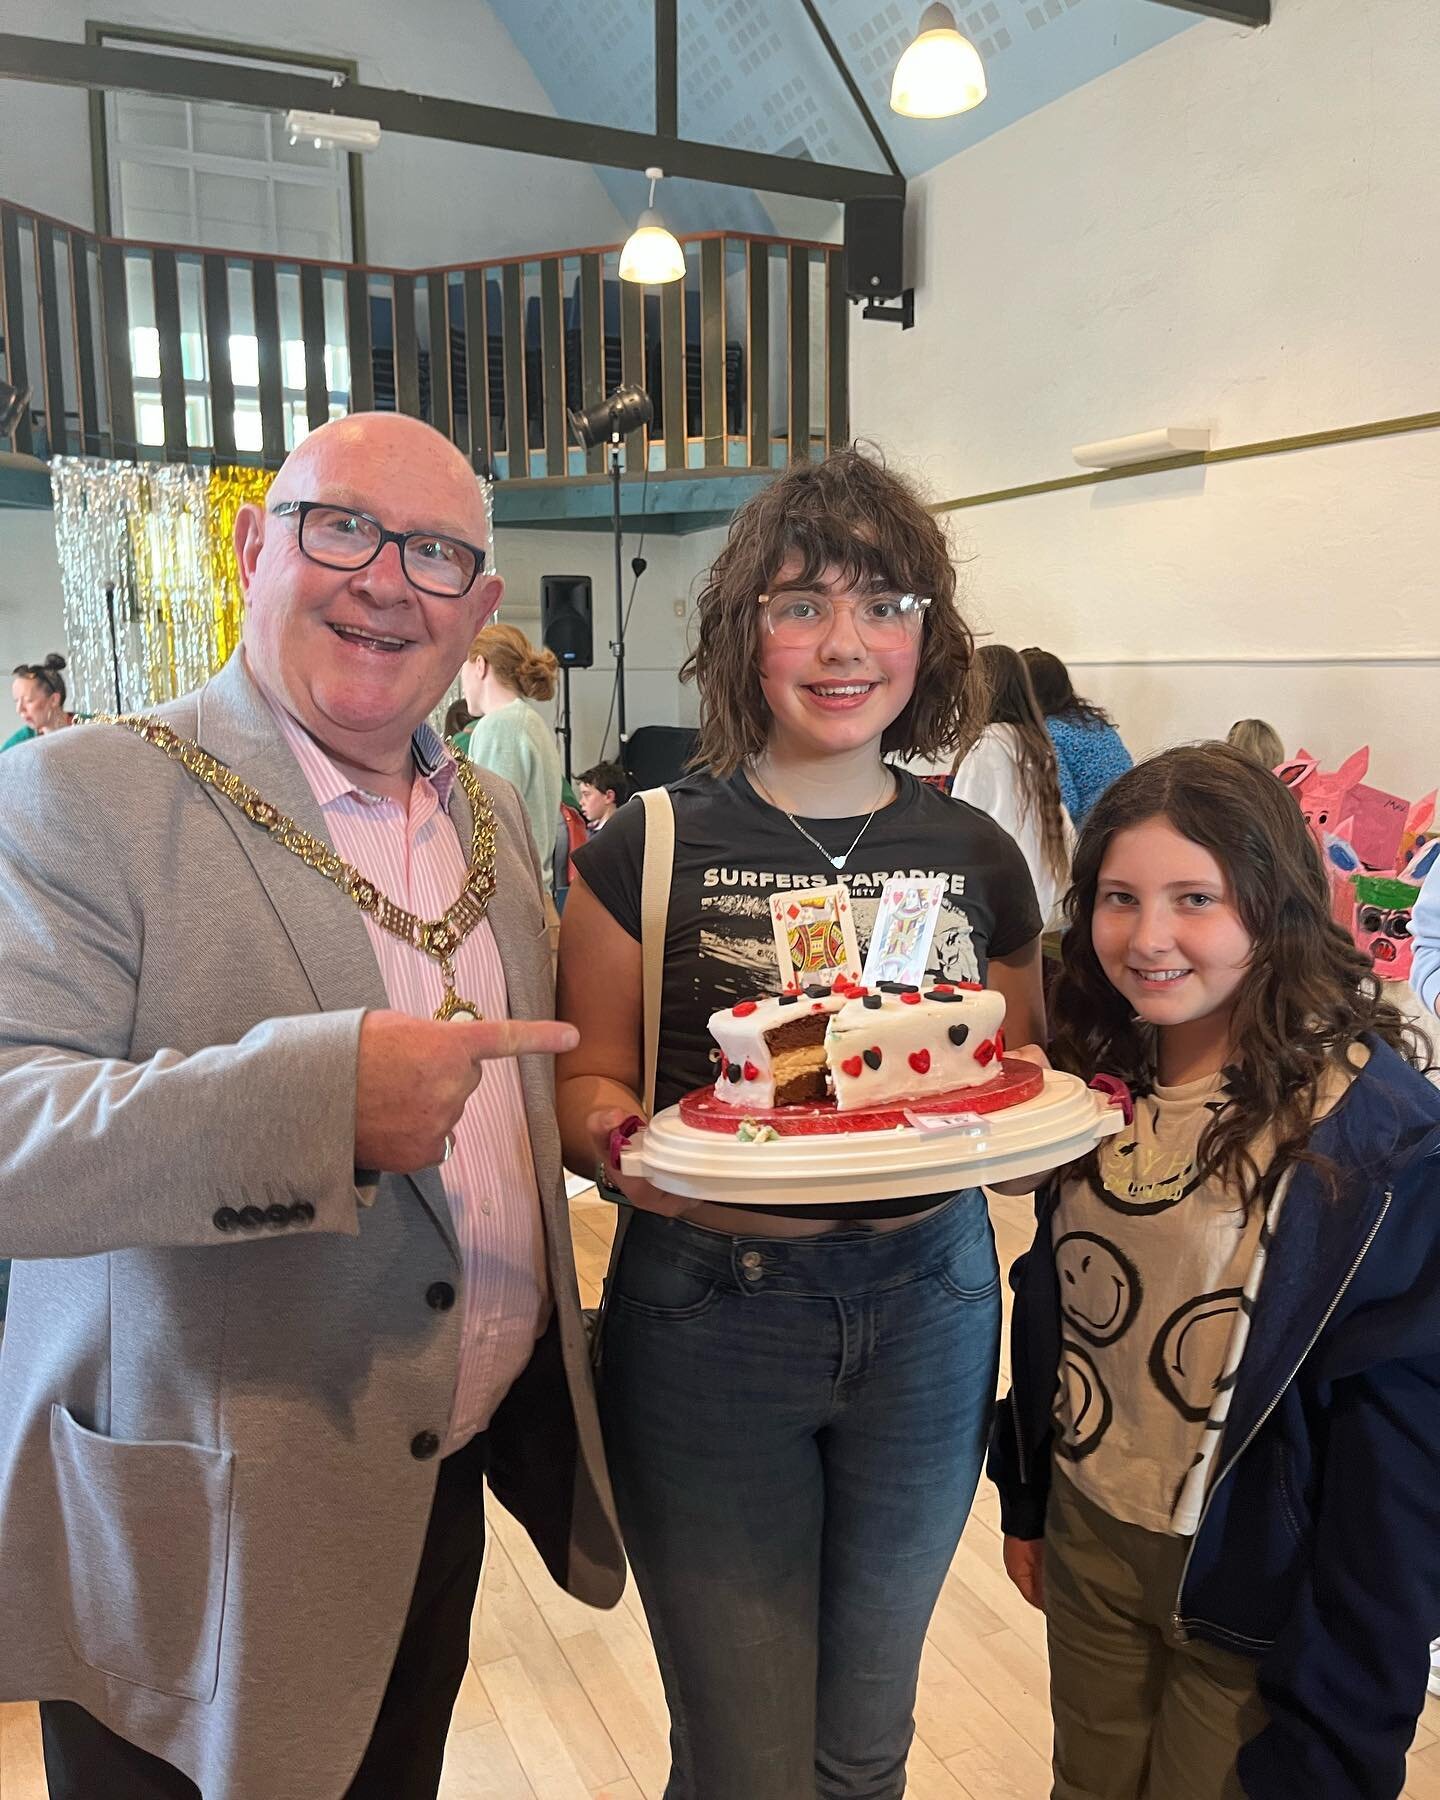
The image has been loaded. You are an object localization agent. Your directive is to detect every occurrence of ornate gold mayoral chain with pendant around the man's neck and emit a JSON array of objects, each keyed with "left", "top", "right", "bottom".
[{"left": 110, "top": 716, "right": 495, "bottom": 1021}]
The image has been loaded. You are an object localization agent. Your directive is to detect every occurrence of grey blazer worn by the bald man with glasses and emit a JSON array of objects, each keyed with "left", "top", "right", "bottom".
[{"left": 0, "top": 655, "right": 625, "bottom": 1800}]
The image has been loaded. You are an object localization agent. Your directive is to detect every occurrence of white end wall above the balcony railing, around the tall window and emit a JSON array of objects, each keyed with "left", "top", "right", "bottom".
[{"left": 0, "top": 0, "right": 628, "bottom": 268}]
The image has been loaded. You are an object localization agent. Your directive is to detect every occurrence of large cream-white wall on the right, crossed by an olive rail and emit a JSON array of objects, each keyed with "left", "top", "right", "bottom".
[{"left": 851, "top": 0, "right": 1440, "bottom": 794}]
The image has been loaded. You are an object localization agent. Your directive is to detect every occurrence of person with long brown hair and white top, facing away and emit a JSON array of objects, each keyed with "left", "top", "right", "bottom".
[{"left": 950, "top": 644, "right": 1075, "bottom": 931}]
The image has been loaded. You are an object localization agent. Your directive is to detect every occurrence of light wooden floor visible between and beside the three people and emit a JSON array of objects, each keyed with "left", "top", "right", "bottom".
[{"left": 0, "top": 1195, "right": 1440, "bottom": 1800}]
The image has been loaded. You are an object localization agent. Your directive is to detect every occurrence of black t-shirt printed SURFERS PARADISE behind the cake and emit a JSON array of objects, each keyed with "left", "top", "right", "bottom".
[{"left": 574, "top": 769, "right": 1040, "bottom": 1217}]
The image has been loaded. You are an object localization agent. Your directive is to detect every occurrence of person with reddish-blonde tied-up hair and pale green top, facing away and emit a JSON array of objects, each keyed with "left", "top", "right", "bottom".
[{"left": 457, "top": 623, "right": 563, "bottom": 895}]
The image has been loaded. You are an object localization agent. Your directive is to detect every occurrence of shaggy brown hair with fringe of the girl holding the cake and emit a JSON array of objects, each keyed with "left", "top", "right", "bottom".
[{"left": 680, "top": 446, "right": 979, "bottom": 778}]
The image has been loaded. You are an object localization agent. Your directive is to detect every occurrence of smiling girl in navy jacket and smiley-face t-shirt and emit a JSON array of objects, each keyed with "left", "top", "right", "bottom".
[{"left": 990, "top": 745, "right": 1440, "bottom": 1800}]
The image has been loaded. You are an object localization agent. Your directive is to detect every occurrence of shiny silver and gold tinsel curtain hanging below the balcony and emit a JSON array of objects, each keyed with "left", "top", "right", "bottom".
[{"left": 50, "top": 457, "right": 274, "bottom": 713}]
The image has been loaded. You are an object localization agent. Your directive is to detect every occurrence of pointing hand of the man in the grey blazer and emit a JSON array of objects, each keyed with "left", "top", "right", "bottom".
[{"left": 355, "top": 1012, "right": 580, "bottom": 1175}]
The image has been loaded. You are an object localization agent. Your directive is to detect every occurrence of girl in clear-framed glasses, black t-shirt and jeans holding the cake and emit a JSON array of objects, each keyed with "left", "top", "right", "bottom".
[{"left": 558, "top": 450, "right": 1042, "bottom": 1800}]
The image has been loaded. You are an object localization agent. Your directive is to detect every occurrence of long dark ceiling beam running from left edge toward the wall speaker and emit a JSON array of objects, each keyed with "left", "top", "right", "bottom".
[{"left": 0, "top": 31, "right": 905, "bottom": 202}]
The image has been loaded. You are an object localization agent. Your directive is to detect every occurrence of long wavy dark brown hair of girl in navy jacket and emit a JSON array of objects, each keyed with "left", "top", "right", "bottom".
[{"left": 1051, "top": 743, "right": 1427, "bottom": 1204}]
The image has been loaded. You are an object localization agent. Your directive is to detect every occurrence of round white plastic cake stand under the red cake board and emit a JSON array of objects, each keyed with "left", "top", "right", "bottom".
[{"left": 619, "top": 1069, "right": 1123, "bottom": 1206}]
